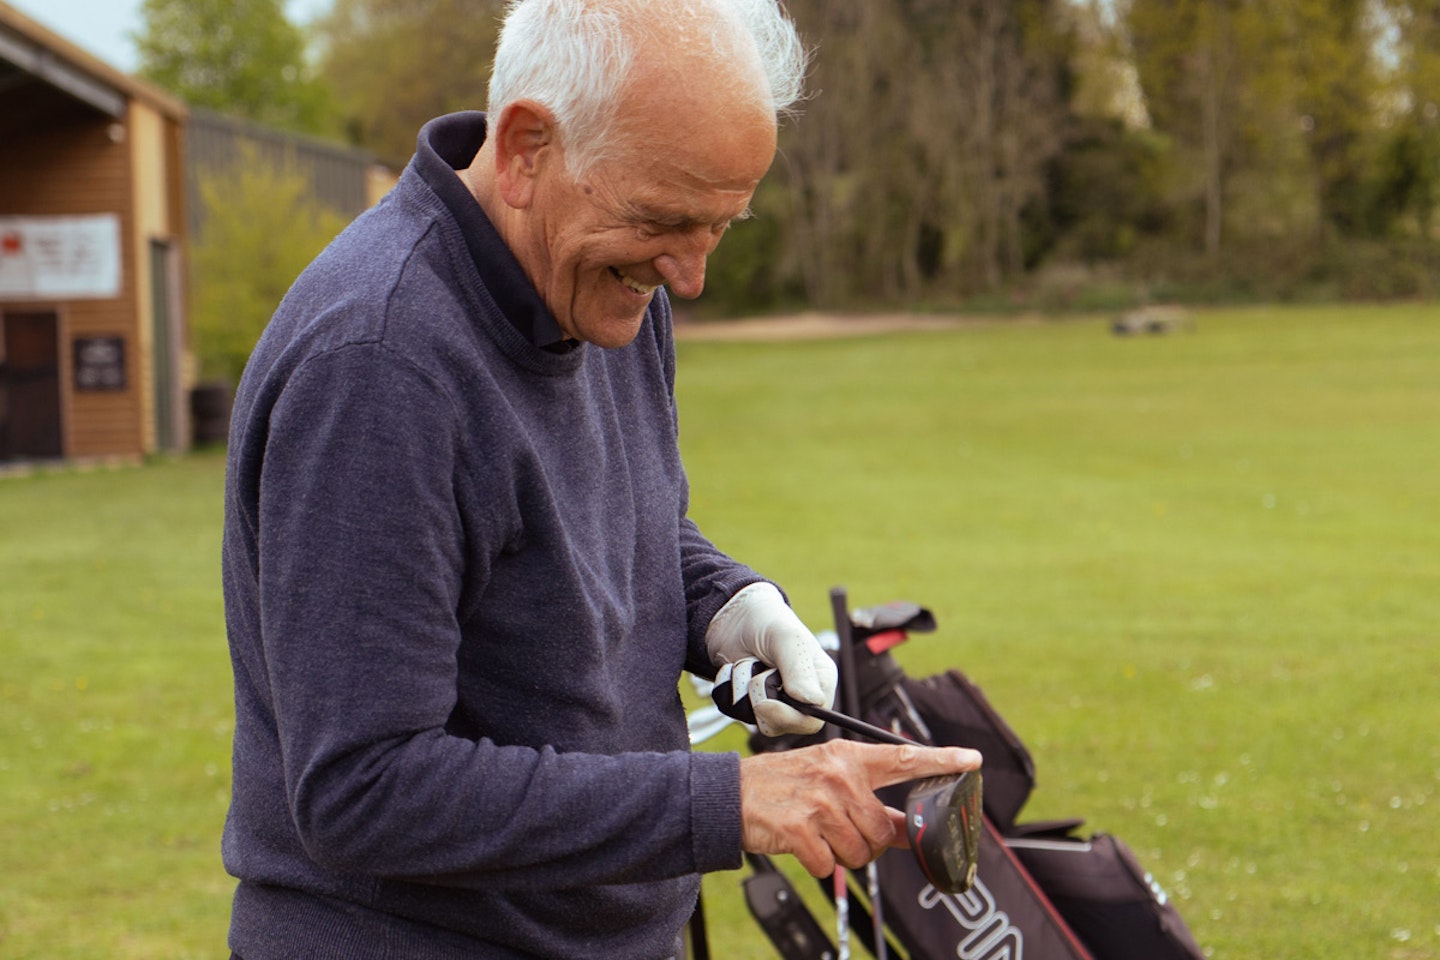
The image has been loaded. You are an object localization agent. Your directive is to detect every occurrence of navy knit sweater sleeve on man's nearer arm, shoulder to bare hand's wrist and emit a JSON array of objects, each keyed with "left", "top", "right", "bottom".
[{"left": 238, "top": 343, "right": 739, "bottom": 889}]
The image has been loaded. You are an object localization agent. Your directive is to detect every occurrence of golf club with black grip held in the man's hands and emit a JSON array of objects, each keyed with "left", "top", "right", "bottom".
[{"left": 711, "top": 659, "right": 982, "bottom": 894}]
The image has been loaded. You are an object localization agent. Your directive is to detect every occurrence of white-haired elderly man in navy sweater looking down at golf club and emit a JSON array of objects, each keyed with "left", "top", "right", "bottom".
[{"left": 223, "top": 0, "right": 978, "bottom": 960}]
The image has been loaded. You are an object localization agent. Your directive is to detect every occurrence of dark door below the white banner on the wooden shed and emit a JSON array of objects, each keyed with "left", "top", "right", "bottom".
[{"left": 0, "top": 311, "right": 62, "bottom": 461}]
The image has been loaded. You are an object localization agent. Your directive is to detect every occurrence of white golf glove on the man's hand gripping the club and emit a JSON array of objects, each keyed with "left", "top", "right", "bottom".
[{"left": 706, "top": 583, "right": 835, "bottom": 737}]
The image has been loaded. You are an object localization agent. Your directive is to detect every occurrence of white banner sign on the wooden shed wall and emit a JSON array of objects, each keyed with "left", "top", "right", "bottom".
[{"left": 0, "top": 213, "right": 120, "bottom": 299}]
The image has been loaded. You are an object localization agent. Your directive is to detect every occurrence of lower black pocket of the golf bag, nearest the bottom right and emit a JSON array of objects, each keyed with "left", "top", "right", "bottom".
[{"left": 1008, "top": 829, "right": 1205, "bottom": 960}]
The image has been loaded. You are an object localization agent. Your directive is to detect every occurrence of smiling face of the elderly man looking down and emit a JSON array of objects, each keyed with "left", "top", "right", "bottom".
[{"left": 486, "top": 51, "right": 776, "bottom": 347}]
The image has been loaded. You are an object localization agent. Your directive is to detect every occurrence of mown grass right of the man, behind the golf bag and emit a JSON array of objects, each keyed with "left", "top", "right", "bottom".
[{"left": 683, "top": 308, "right": 1440, "bottom": 960}]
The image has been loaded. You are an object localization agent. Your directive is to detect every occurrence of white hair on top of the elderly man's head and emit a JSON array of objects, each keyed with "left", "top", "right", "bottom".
[{"left": 487, "top": 0, "right": 808, "bottom": 177}]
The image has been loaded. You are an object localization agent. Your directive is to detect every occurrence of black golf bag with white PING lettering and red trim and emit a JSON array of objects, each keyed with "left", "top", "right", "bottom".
[{"left": 731, "top": 592, "right": 1204, "bottom": 960}]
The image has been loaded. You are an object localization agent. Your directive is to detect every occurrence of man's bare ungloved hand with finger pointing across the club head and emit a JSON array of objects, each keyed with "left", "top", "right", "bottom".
[{"left": 740, "top": 740, "right": 981, "bottom": 877}]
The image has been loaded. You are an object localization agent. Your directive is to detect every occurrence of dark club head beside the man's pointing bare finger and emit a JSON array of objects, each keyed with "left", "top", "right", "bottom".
[{"left": 904, "top": 771, "right": 981, "bottom": 894}]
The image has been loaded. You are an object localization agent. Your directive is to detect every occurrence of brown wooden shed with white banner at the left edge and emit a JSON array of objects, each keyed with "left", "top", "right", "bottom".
[{"left": 0, "top": 1, "right": 190, "bottom": 462}]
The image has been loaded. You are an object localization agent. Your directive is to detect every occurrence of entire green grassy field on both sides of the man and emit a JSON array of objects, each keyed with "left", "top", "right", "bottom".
[{"left": 0, "top": 307, "right": 1440, "bottom": 960}]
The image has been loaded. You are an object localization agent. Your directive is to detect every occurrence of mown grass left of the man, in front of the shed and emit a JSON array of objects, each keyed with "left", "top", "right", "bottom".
[{"left": 0, "top": 455, "right": 233, "bottom": 960}]
